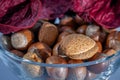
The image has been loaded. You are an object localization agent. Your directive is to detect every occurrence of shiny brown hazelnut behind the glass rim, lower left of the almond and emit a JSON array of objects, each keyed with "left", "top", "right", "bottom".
[{"left": 46, "top": 56, "right": 68, "bottom": 80}]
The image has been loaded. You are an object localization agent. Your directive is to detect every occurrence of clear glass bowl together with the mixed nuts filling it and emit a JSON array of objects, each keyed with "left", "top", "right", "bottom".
[{"left": 0, "top": 16, "right": 120, "bottom": 80}]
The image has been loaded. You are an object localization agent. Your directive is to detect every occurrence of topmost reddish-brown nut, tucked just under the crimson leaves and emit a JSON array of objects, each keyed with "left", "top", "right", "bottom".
[{"left": 60, "top": 16, "right": 75, "bottom": 27}]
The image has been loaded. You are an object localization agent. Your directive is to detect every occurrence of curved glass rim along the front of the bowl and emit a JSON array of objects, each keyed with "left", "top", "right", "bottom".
[{"left": 0, "top": 33, "right": 120, "bottom": 68}]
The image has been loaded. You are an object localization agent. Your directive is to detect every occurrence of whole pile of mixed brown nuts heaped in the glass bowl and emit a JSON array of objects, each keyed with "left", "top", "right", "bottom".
[{"left": 2, "top": 16, "right": 120, "bottom": 80}]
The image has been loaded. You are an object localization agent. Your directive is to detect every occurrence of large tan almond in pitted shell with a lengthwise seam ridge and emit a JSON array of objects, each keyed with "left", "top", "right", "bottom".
[{"left": 60, "top": 34, "right": 98, "bottom": 59}]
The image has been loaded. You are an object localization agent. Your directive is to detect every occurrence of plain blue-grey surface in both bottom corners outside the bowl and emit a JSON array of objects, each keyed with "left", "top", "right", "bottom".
[{"left": 0, "top": 63, "right": 120, "bottom": 80}]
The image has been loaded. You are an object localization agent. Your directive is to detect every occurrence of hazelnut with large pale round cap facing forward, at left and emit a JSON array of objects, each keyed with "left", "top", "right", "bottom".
[{"left": 11, "top": 29, "right": 33, "bottom": 50}]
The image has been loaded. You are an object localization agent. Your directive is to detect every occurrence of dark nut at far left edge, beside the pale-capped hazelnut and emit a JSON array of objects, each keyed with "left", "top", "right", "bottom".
[{"left": 1, "top": 35, "right": 13, "bottom": 50}]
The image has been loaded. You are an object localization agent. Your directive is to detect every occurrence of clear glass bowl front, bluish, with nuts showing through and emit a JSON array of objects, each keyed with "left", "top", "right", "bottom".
[{"left": 0, "top": 35, "right": 120, "bottom": 80}]
